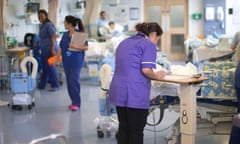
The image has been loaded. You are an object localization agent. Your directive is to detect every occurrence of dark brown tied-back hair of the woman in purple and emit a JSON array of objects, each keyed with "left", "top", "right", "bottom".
[{"left": 135, "top": 22, "right": 163, "bottom": 36}]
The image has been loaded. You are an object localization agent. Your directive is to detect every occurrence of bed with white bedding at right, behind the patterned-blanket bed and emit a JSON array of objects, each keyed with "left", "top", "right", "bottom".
[{"left": 184, "top": 36, "right": 234, "bottom": 64}]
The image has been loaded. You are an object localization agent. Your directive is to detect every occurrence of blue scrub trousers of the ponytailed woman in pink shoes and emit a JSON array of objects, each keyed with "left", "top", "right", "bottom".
[{"left": 64, "top": 68, "right": 81, "bottom": 107}]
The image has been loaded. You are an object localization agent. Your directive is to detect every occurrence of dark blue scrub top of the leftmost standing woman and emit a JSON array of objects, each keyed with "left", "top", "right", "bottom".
[{"left": 39, "top": 22, "right": 57, "bottom": 54}]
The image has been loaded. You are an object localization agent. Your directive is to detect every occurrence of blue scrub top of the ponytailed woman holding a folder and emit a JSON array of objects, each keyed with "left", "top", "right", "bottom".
[{"left": 60, "top": 32, "right": 87, "bottom": 69}]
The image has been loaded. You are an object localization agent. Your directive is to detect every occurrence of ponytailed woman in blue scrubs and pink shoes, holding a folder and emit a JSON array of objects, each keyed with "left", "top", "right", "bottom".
[{"left": 58, "top": 15, "right": 88, "bottom": 111}]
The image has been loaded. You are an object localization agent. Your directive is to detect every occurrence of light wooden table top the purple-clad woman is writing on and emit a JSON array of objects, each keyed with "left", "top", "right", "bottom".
[{"left": 160, "top": 75, "right": 208, "bottom": 84}]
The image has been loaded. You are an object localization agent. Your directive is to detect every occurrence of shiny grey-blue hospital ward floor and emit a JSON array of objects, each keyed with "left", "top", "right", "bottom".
[{"left": 0, "top": 69, "right": 229, "bottom": 144}]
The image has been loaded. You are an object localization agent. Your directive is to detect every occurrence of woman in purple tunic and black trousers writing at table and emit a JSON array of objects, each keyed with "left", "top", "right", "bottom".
[{"left": 109, "top": 23, "right": 166, "bottom": 144}]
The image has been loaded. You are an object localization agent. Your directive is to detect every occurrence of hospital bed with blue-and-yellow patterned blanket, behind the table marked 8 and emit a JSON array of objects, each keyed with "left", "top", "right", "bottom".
[{"left": 150, "top": 61, "right": 237, "bottom": 144}]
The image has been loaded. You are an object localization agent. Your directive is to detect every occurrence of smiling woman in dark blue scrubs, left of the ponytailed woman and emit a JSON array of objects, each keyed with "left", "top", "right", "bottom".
[{"left": 38, "top": 10, "right": 59, "bottom": 91}]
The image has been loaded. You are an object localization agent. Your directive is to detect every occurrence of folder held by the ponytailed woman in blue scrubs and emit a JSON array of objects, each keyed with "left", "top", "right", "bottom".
[{"left": 69, "top": 32, "right": 88, "bottom": 51}]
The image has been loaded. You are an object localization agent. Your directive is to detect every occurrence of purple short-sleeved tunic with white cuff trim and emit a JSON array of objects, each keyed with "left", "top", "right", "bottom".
[{"left": 109, "top": 33, "right": 156, "bottom": 109}]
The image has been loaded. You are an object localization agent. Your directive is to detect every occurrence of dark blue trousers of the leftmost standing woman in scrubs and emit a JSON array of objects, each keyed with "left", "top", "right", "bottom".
[{"left": 39, "top": 53, "right": 59, "bottom": 89}]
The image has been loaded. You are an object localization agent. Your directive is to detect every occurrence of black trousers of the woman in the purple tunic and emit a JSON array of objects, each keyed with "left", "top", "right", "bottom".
[{"left": 117, "top": 107, "right": 148, "bottom": 144}]
